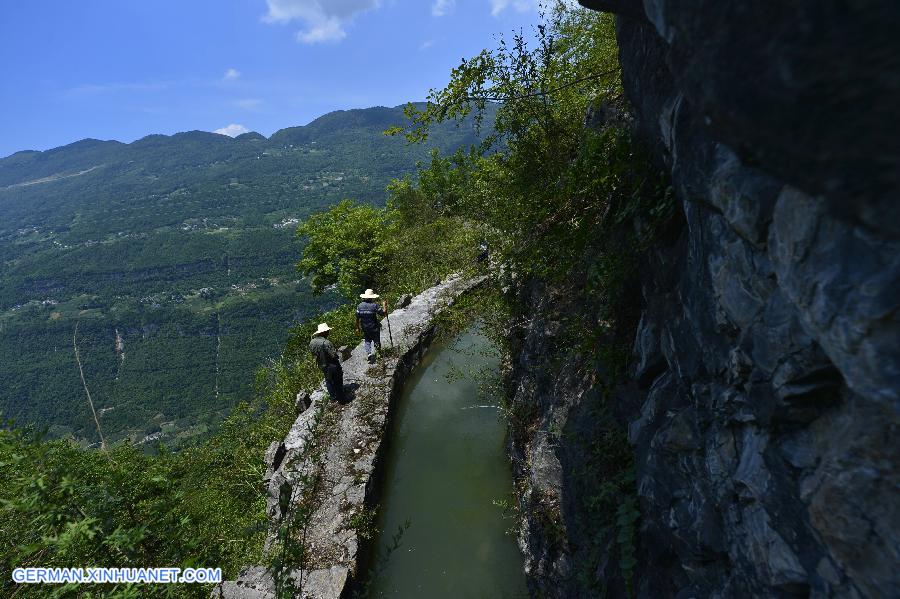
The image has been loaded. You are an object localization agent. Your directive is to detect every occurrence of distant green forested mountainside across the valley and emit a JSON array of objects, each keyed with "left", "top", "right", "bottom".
[{"left": 0, "top": 108, "right": 492, "bottom": 444}]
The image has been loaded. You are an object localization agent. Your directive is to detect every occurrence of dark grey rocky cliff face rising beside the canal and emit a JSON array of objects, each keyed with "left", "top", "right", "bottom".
[{"left": 510, "top": 0, "right": 900, "bottom": 597}]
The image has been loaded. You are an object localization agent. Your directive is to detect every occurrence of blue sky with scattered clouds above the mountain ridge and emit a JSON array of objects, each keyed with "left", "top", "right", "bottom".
[{"left": 0, "top": 0, "right": 537, "bottom": 156}]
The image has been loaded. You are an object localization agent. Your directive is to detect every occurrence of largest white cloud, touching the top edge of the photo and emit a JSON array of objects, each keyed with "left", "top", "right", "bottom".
[{"left": 263, "top": 0, "right": 381, "bottom": 44}]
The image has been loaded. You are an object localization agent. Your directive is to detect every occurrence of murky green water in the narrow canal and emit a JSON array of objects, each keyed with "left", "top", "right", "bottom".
[{"left": 369, "top": 327, "right": 528, "bottom": 598}]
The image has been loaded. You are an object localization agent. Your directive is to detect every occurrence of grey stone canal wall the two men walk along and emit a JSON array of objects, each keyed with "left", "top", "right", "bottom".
[{"left": 212, "top": 277, "right": 484, "bottom": 599}]
